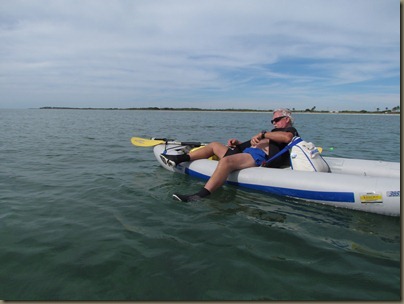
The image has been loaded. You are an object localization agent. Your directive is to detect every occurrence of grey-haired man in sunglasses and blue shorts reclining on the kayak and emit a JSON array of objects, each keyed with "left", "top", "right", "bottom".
[{"left": 160, "top": 109, "right": 299, "bottom": 202}]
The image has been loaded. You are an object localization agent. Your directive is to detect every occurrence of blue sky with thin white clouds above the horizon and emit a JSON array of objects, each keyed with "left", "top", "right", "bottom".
[{"left": 0, "top": 0, "right": 400, "bottom": 111}]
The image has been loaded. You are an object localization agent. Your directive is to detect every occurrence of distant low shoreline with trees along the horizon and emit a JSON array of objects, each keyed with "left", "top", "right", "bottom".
[{"left": 39, "top": 107, "right": 400, "bottom": 114}]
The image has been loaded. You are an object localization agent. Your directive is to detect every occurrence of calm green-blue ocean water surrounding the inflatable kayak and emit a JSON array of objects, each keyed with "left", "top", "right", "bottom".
[{"left": 0, "top": 109, "right": 401, "bottom": 300}]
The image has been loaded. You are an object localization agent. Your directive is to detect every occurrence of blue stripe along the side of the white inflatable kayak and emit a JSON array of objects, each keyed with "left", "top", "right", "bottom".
[{"left": 185, "top": 168, "right": 355, "bottom": 203}]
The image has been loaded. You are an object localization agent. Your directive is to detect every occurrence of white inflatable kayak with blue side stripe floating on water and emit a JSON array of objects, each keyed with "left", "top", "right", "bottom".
[{"left": 154, "top": 144, "right": 400, "bottom": 216}]
